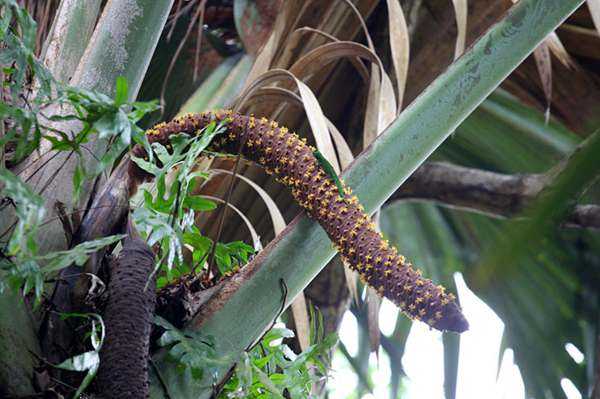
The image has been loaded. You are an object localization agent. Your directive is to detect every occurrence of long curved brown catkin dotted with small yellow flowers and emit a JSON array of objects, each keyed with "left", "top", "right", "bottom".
[{"left": 133, "top": 111, "right": 468, "bottom": 332}]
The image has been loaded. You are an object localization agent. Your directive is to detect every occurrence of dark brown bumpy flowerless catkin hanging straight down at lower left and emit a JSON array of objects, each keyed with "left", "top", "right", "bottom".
[{"left": 97, "top": 238, "right": 156, "bottom": 399}]
